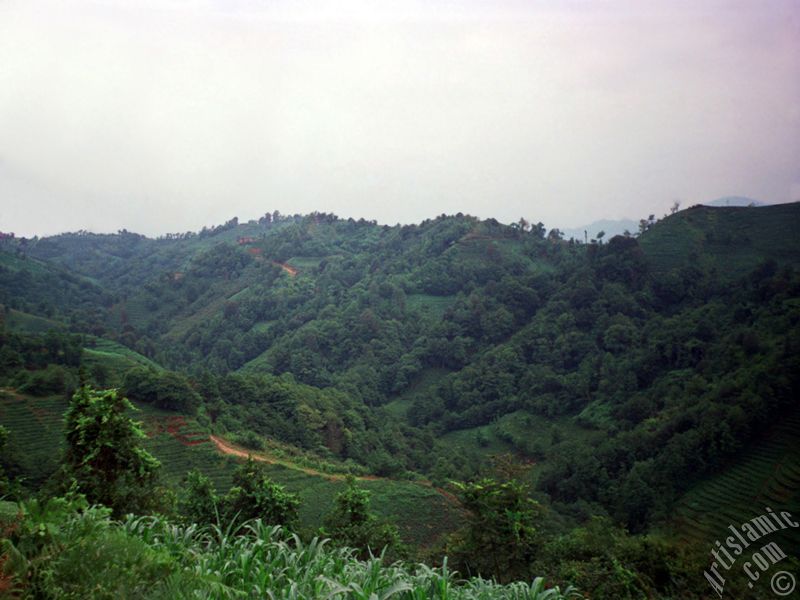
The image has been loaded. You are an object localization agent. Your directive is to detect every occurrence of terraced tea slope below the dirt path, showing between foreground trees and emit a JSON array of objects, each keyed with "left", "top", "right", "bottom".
[{"left": 0, "top": 390, "right": 458, "bottom": 547}]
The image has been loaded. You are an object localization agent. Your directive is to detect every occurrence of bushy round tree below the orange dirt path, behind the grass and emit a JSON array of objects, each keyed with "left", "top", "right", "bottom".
[{"left": 223, "top": 458, "right": 300, "bottom": 528}]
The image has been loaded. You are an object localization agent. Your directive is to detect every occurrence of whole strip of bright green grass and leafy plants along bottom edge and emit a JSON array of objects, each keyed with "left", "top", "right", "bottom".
[{"left": 0, "top": 499, "right": 580, "bottom": 600}]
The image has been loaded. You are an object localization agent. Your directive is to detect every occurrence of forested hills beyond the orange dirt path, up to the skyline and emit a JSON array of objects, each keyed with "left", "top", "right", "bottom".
[{"left": 0, "top": 204, "right": 800, "bottom": 597}]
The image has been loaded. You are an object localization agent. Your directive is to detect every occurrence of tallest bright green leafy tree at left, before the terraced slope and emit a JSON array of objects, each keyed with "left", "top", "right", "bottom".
[{"left": 63, "top": 385, "right": 161, "bottom": 516}]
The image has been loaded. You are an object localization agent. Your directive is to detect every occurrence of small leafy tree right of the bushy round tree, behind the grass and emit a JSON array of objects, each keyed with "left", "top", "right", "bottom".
[{"left": 322, "top": 475, "right": 400, "bottom": 560}]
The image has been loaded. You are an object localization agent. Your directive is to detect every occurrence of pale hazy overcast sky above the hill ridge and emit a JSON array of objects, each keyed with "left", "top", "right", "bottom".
[{"left": 0, "top": 0, "right": 800, "bottom": 235}]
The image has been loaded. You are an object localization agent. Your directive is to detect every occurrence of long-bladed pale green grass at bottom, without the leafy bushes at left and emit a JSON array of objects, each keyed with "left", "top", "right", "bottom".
[{"left": 122, "top": 517, "right": 579, "bottom": 600}]
